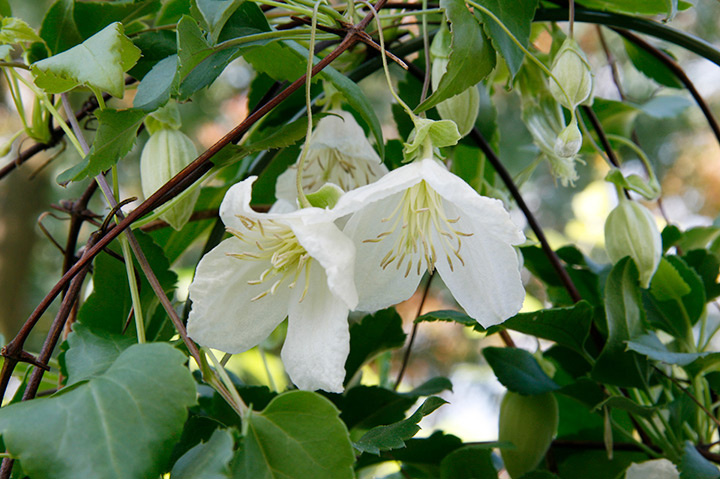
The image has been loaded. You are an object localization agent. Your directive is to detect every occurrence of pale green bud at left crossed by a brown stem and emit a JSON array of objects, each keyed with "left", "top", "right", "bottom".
[{"left": 140, "top": 129, "right": 200, "bottom": 230}]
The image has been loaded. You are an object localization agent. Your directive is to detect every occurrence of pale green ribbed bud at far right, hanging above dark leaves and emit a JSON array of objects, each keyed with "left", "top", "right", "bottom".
[{"left": 605, "top": 198, "right": 662, "bottom": 288}]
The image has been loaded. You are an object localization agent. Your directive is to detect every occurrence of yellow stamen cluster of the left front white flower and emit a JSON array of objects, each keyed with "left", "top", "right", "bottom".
[{"left": 228, "top": 215, "right": 312, "bottom": 301}]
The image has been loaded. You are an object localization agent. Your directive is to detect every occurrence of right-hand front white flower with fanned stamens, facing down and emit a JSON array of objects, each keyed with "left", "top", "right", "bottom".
[{"left": 334, "top": 158, "right": 525, "bottom": 327}]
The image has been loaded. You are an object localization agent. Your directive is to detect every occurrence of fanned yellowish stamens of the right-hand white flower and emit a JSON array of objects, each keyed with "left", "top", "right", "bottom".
[{"left": 363, "top": 180, "right": 472, "bottom": 277}]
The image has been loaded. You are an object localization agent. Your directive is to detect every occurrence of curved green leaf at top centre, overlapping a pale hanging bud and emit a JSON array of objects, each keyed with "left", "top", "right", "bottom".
[{"left": 415, "top": 0, "right": 495, "bottom": 113}]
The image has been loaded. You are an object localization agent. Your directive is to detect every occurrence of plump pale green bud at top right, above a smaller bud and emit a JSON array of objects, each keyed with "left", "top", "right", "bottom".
[{"left": 549, "top": 38, "right": 593, "bottom": 110}]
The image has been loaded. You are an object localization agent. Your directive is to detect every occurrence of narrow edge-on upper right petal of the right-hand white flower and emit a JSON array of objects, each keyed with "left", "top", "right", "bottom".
[{"left": 418, "top": 159, "right": 525, "bottom": 244}]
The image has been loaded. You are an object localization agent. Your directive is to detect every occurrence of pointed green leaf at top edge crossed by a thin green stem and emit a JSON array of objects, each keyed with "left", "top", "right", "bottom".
[{"left": 476, "top": 0, "right": 538, "bottom": 78}]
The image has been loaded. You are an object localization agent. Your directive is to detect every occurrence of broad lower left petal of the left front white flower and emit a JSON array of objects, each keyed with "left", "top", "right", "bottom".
[{"left": 187, "top": 237, "right": 291, "bottom": 353}]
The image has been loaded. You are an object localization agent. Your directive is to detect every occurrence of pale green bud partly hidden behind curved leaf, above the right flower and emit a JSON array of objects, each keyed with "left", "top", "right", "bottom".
[{"left": 430, "top": 21, "right": 480, "bottom": 136}]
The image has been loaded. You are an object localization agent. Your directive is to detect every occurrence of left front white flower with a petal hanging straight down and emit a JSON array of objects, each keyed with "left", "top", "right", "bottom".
[{"left": 188, "top": 177, "right": 358, "bottom": 392}]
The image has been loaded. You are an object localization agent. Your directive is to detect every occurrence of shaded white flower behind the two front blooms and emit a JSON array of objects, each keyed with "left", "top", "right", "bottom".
[{"left": 275, "top": 110, "right": 388, "bottom": 205}]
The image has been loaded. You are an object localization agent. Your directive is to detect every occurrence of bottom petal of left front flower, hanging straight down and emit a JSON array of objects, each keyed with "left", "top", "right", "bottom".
[{"left": 281, "top": 264, "right": 350, "bottom": 393}]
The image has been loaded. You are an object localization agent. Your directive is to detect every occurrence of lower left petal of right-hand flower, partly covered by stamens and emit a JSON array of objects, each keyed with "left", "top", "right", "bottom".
[{"left": 343, "top": 193, "right": 425, "bottom": 311}]
